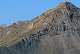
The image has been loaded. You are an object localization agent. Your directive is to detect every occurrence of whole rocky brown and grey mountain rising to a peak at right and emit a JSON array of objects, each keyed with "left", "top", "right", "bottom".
[{"left": 0, "top": 2, "right": 80, "bottom": 54}]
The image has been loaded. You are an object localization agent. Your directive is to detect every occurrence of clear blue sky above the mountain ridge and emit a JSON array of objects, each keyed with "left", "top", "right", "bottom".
[{"left": 0, "top": 0, "right": 80, "bottom": 25}]
